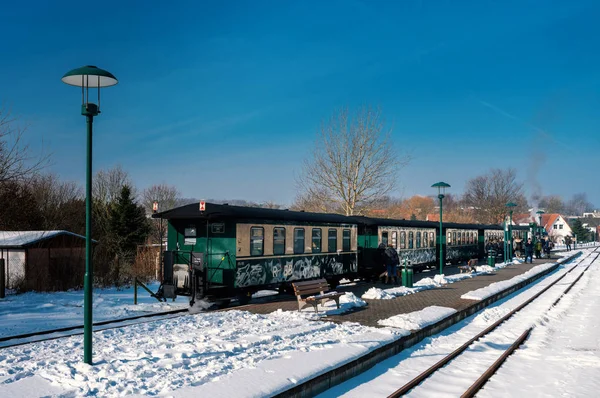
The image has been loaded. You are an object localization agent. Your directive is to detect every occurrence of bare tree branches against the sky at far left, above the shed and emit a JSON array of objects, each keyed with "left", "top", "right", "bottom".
[{"left": 0, "top": 108, "right": 50, "bottom": 183}]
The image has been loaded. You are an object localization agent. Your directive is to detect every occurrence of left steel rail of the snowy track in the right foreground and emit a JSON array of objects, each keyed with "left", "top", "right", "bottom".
[{"left": 388, "top": 247, "right": 600, "bottom": 398}]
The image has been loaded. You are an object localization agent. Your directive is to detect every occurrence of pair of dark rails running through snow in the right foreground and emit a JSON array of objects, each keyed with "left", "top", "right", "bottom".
[{"left": 388, "top": 249, "right": 600, "bottom": 398}]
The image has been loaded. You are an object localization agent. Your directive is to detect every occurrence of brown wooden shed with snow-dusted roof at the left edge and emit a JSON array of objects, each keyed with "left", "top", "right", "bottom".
[{"left": 0, "top": 231, "right": 85, "bottom": 291}]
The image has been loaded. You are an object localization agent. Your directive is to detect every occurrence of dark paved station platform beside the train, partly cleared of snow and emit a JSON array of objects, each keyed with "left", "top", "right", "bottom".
[{"left": 238, "top": 256, "right": 559, "bottom": 327}]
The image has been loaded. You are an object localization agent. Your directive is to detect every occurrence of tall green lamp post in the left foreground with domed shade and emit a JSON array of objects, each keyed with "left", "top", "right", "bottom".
[{"left": 61, "top": 65, "right": 117, "bottom": 365}]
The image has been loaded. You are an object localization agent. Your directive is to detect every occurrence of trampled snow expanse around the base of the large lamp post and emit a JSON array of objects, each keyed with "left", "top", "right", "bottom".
[{"left": 0, "top": 308, "right": 400, "bottom": 397}]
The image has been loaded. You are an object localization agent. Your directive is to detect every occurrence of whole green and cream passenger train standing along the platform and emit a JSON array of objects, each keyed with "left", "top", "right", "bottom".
[{"left": 152, "top": 202, "right": 530, "bottom": 305}]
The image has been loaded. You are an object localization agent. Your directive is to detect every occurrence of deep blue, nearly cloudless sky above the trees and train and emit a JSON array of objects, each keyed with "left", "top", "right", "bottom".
[{"left": 0, "top": 0, "right": 600, "bottom": 206}]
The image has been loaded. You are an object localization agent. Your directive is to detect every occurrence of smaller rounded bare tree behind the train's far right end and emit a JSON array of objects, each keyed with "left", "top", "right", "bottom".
[{"left": 463, "top": 169, "right": 527, "bottom": 224}]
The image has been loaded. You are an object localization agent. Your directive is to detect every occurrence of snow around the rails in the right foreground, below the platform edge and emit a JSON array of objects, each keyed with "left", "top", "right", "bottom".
[{"left": 320, "top": 247, "right": 600, "bottom": 397}]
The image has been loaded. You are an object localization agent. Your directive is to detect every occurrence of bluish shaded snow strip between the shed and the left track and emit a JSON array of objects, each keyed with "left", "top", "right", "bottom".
[{"left": 0, "top": 282, "right": 189, "bottom": 337}]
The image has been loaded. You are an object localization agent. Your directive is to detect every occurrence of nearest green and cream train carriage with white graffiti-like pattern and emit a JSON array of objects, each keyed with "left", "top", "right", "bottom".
[{"left": 153, "top": 203, "right": 358, "bottom": 302}]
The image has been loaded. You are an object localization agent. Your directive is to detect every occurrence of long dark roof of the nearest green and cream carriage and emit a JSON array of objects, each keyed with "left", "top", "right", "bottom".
[{"left": 152, "top": 203, "right": 356, "bottom": 224}]
